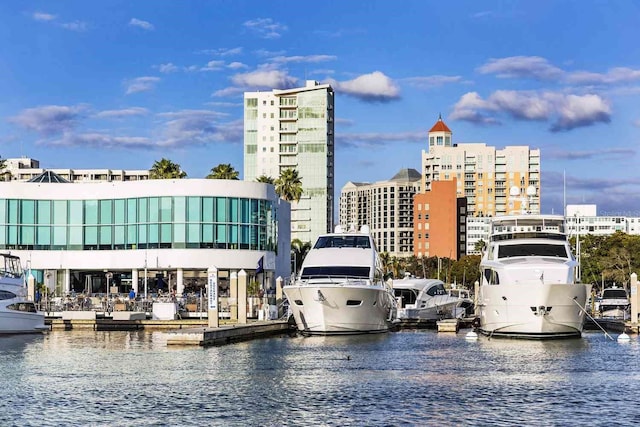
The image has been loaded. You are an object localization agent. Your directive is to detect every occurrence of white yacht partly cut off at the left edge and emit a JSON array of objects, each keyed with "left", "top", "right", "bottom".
[{"left": 0, "top": 253, "right": 48, "bottom": 334}]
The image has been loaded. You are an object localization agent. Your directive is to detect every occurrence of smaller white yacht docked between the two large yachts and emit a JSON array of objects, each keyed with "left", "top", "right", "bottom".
[{"left": 393, "top": 276, "right": 473, "bottom": 320}]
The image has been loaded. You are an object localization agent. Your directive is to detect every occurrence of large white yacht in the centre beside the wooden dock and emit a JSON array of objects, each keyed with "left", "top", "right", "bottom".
[{"left": 283, "top": 226, "right": 396, "bottom": 335}]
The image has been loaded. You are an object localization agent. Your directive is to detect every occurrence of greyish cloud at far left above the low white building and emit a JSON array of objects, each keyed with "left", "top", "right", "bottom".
[{"left": 9, "top": 105, "right": 86, "bottom": 136}]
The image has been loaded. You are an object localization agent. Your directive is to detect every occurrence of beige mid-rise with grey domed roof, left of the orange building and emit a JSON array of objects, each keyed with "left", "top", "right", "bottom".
[{"left": 340, "top": 169, "right": 422, "bottom": 257}]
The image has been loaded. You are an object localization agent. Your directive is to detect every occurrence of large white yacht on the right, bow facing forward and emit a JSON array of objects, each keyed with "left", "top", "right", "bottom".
[{"left": 478, "top": 215, "right": 591, "bottom": 338}]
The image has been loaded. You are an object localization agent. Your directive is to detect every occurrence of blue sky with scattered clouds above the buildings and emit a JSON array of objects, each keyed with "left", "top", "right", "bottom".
[{"left": 0, "top": 0, "right": 640, "bottom": 216}]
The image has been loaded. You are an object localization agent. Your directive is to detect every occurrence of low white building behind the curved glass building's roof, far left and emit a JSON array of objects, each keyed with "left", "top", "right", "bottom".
[{"left": 5, "top": 157, "right": 149, "bottom": 182}]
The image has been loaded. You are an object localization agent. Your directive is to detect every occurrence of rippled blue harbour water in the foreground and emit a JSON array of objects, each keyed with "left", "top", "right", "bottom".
[{"left": 0, "top": 331, "right": 640, "bottom": 426}]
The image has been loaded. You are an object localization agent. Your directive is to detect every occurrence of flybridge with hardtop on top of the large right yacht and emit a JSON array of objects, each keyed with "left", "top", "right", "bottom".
[{"left": 490, "top": 215, "right": 566, "bottom": 241}]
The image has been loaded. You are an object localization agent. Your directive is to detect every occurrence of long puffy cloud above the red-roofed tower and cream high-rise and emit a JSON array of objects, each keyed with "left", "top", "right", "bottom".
[{"left": 450, "top": 91, "right": 611, "bottom": 132}]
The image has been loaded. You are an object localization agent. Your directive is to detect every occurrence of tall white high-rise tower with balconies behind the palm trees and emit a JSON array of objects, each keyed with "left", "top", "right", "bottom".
[{"left": 244, "top": 80, "right": 334, "bottom": 246}]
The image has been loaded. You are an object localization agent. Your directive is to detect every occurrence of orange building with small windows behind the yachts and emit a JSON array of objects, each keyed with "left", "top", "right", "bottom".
[{"left": 413, "top": 178, "right": 467, "bottom": 259}]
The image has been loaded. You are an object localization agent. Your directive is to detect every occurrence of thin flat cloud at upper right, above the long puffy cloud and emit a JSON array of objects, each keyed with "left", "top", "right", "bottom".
[{"left": 478, "top": 56, "right": 564, "bottom": 80}]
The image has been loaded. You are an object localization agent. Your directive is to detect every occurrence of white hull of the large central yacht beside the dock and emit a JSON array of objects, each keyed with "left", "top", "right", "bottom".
[{"left": 283, "top": 284, "right": 394, "bottom": 335}]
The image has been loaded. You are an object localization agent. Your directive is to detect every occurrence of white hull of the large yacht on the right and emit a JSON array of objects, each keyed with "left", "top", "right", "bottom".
[{"left": 478, "top": 284, "right": 591, "bottom": 338}]
